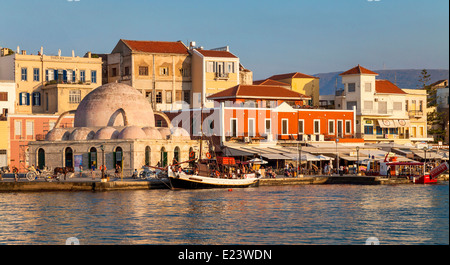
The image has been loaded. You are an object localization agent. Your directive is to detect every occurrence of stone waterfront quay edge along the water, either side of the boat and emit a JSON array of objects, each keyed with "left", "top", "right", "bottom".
[{"left": 0, "top": 174, "right": 449, "bottom": 192}]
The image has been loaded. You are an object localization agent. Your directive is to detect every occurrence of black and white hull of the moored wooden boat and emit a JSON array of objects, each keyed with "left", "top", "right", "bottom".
[{"left": 169, "top": 171, "right": 259, "bottom": 189}]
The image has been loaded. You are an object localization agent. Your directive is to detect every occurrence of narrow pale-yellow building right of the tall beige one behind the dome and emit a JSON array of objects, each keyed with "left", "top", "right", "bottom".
[{"left": 192, "top": 47, "right": 241, "bottom": 108}]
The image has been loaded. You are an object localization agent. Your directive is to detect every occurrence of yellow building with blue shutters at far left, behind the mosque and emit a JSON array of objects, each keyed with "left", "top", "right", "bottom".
[{"left": 0, "top": 48, "right": 102, "bottom": 114}]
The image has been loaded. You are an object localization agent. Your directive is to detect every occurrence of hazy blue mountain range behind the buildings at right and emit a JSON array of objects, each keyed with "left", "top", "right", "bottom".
[{"left": 314, "top": 69, "right": 449, "bottom": 95}]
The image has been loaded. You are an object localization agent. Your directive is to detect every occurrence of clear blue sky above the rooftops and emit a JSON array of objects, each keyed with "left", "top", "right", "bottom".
[{"left": 0, "top": 0, "right": 449, "bottom": 80}]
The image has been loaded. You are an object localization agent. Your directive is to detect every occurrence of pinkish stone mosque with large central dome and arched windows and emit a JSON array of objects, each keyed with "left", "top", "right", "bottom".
[{"left": 29, "top": 83, "right": 208, "bottom": 173}]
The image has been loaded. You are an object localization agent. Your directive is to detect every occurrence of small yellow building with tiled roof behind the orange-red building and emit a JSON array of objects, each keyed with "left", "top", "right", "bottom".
[{"left": 268, "top": 72, "right": 320, "bottom": 106}]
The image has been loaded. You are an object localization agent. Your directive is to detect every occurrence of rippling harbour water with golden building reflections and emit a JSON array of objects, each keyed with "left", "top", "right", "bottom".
[{"left": 0, "top": 182, "right": 449, "bottom": 244}]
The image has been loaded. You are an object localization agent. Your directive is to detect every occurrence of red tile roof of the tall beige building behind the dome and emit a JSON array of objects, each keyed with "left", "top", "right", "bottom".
[{"left": 122, "top": 39, "right": 189, "bottom": 54}]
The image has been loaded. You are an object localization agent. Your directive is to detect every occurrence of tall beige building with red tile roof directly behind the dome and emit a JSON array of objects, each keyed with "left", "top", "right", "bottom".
[{"left": 107, "top": 39, "right": 192, "bottom": 111}]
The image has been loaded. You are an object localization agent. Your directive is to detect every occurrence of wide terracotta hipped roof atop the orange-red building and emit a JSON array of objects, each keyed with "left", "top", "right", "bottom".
[{"left": 207, "top": 85, "right": 311, "bottom": 100}]
